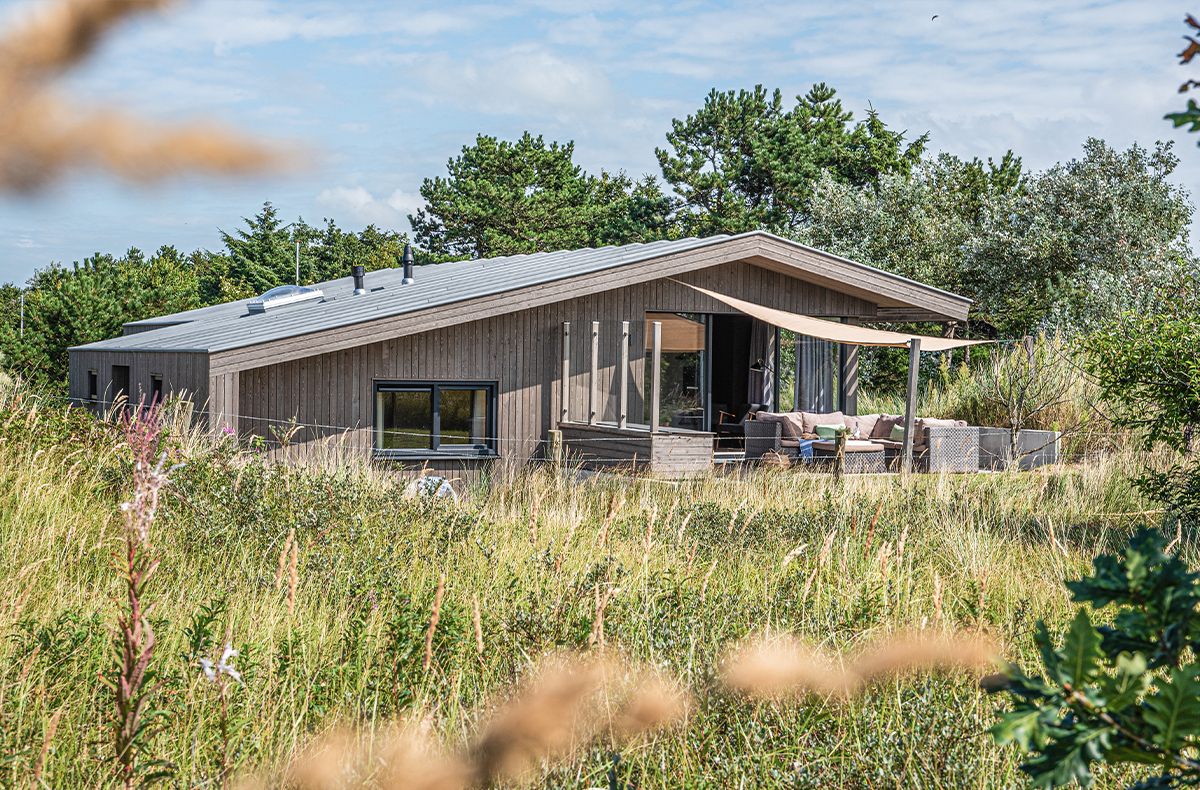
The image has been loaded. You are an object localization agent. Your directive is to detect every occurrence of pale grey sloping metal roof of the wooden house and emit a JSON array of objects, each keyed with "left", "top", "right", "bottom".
[{"left": 68, "top": 231, "right": 970, "bottom": 353}]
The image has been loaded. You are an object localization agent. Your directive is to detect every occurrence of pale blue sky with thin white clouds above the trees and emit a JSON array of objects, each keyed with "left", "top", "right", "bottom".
[{"left": 0, "top": 0, "right": 1200, "bottom": 282}]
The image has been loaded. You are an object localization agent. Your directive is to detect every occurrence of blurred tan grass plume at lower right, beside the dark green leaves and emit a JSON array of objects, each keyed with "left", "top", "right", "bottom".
[{"left": 722, "top": 635, "right": 996, "bottom": 699}]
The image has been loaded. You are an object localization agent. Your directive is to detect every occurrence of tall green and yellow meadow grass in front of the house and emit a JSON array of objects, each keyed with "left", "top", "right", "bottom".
[{"left": 0, "top": 396, "right": 1180, "bottom": 789}]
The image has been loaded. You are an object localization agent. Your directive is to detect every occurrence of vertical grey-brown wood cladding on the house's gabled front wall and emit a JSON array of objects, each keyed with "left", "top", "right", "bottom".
[{"left": 231, "top": 262, "right": 875, "bottom": 468}]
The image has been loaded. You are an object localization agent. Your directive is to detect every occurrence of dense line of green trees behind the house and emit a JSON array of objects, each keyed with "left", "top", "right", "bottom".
[{"left": 0, "top": 84, "right": 1195, "bottom": 384}]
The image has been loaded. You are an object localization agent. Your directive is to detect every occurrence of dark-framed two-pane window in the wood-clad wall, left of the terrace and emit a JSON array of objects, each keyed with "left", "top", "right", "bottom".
[{"left": 374, "top": 382, "right": 496, "bottom": 455}]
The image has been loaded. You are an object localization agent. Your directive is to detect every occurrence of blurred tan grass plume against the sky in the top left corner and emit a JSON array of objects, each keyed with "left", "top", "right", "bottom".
[{"left": 0, "top": 0, "right": 284, "bottom": 191}]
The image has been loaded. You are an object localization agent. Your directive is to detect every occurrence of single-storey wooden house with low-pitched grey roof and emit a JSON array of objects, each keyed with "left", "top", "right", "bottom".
[{"left": 70, "top": 232, "right": 970, "bottom": 475}]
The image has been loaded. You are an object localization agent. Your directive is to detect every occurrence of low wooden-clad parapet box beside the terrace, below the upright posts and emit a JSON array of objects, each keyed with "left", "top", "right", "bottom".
[{"left": 558, "top": 423, "right": 713, "bottom": 478}]
